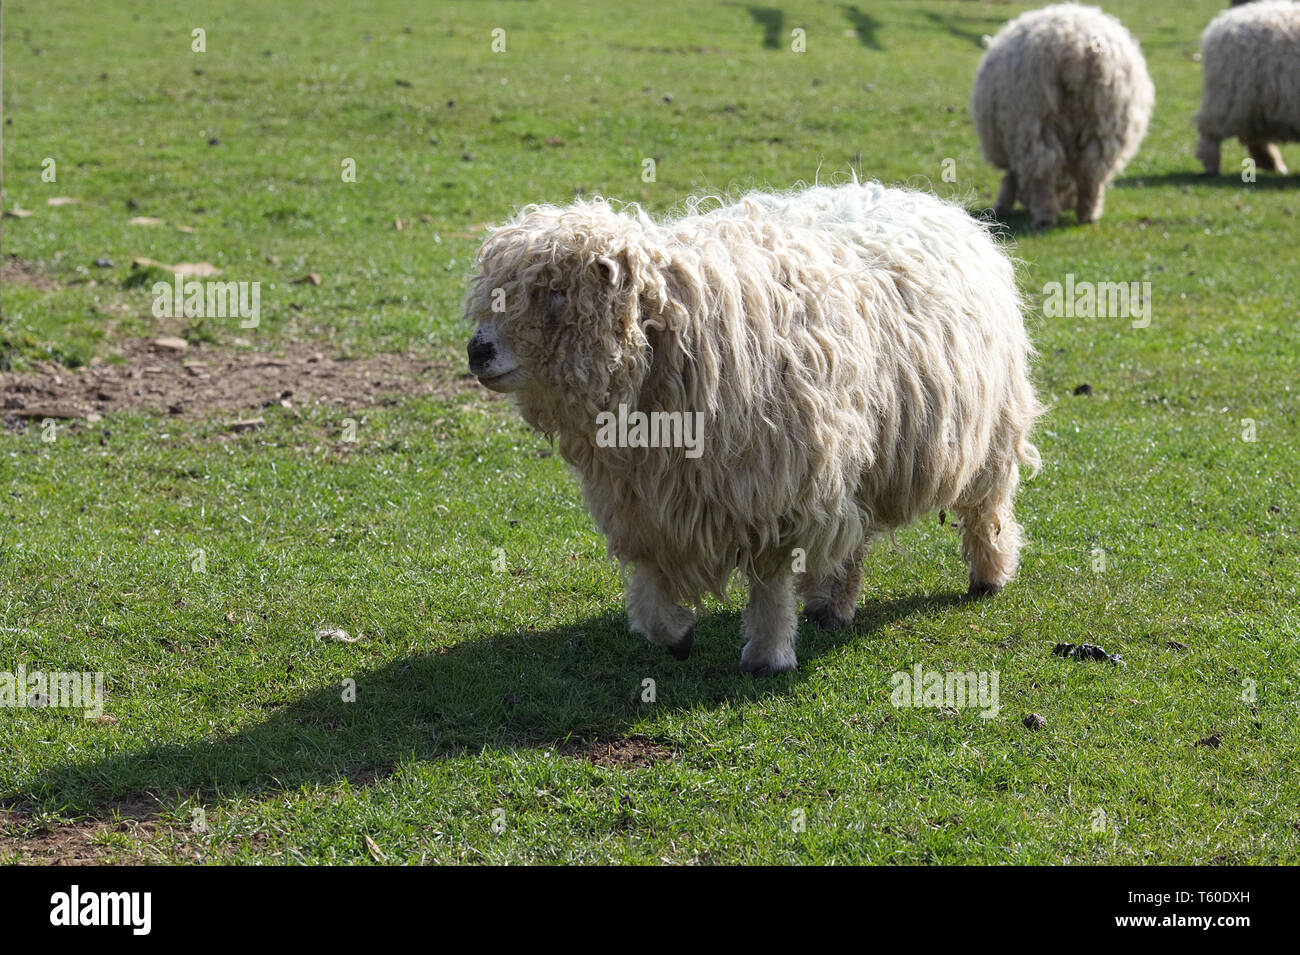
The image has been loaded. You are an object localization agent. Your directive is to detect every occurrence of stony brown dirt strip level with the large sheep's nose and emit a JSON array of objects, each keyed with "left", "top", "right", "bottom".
[{"left": 0, "top": 340, "right": 478, "bottom": 430}]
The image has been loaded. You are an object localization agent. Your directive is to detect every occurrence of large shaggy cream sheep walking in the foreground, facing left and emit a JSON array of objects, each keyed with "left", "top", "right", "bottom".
[{"left": 465, "top": 182, "right": 1040, "bottom": 672}]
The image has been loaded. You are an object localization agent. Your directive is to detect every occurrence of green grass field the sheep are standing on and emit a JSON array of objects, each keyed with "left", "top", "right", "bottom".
[{"left": 0, "top": 0, "right": 1300, "bottom": 864}]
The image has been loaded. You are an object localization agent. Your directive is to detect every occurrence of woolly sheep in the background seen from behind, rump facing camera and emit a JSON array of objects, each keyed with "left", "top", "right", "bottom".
[{"left": 971, "top": 4, "right": 1156, "bottom": 229}]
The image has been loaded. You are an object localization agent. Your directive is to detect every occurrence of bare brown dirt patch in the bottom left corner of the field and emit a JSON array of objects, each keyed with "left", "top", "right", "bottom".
[{"left": 0, "top": 796, "right": 185, "bottom": 865}]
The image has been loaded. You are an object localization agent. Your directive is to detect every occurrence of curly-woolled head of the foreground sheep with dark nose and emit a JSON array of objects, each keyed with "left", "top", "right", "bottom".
[{"left": 465, "top": 205, "right": 649, "bottom": 407}]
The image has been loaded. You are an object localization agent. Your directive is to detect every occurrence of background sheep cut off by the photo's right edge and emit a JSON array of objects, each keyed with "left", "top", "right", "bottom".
[{"left": 1196, "top": 0, "right": 1300, "bottom": 175}]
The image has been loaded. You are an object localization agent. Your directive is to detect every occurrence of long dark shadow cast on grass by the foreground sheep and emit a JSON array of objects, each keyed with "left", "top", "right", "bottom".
[{"left": 0, "top": 594, "right": 966, "bottom": 820}]
